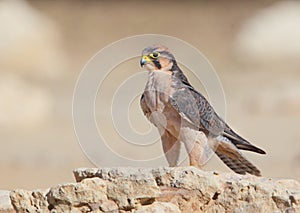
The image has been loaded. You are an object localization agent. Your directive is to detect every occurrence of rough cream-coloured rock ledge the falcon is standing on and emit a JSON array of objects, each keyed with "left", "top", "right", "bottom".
[{"left": 10, "top": 167, "right": 300, "bottom": 212}]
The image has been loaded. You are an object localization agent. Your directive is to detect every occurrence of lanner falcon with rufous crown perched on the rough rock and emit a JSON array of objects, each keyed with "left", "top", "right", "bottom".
[{"left": 140, "top": 46, "right": 265, "bottom": 176}]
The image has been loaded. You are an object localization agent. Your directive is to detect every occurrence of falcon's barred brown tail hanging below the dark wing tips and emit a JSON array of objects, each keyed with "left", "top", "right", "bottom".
[{"left": 215, "top": 137, "right": 261, "bottom": 176}]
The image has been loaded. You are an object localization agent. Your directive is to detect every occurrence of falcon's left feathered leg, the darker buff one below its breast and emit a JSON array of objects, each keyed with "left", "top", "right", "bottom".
[{"left": 161, "top": 130, "right": 180, "bottom": 166}]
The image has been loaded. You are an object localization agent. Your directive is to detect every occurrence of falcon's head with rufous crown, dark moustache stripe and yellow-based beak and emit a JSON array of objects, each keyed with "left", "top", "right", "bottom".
[{"left": 140, "top": 45, "right": 176, "bottom": 71}]
